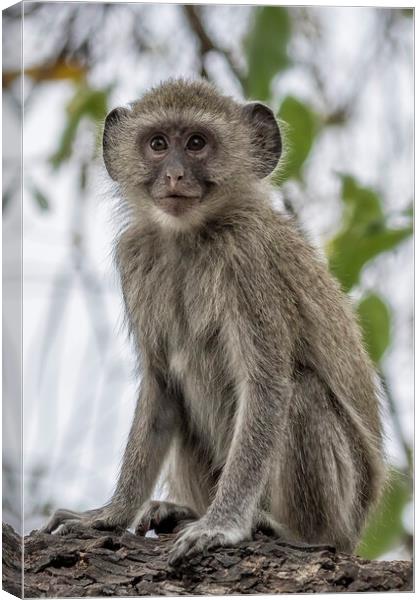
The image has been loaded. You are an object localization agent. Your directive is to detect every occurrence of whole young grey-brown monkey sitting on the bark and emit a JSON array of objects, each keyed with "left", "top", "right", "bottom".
[{"left": 44, "top": 79, "right": 385, "bottom": 566}]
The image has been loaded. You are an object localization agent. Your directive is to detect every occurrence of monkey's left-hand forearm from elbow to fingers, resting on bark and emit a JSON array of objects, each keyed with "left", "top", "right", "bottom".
[{"left": 42, "top": 372, "right": 178, "bottom": 533}]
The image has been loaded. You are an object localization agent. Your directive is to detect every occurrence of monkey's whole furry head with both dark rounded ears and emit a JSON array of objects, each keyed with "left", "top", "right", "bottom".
[{"left": 103, "top": 80, "right": 282, "bottom": 228}]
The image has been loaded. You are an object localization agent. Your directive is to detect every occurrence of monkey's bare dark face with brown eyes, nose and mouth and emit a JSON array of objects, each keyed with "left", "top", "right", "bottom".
[{"left": 138, "top": 127, "right": 217, "bottom": 216}]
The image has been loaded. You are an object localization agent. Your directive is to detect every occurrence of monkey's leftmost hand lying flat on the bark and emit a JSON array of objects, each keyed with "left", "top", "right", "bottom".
[{"left": 40, "top": 505, "right": 129, "bottom": 535}]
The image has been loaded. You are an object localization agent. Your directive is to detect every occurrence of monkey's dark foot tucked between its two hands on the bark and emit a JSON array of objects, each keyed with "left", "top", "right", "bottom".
[{"left": 136, "top": 500, "right": 198, "bottom": 535}]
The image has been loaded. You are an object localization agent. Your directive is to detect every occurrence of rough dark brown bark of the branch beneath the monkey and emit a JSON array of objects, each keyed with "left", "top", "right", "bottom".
[{"left": 3, "top": 525, "right": 412, "bottom": 597}]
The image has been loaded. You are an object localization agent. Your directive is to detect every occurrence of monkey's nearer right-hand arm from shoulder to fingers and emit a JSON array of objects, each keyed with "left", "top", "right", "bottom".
[{"left": 170, "top": 262, "right": 292, "bottom": 564}]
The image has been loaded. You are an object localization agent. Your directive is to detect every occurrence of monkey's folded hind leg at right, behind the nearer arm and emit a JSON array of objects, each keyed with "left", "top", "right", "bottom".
[{"left": 278, "top": 370, "right": 363, "bottom": 552}]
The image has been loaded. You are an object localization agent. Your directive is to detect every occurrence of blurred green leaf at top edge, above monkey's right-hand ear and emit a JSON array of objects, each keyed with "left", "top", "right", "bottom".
[{"left": 245, "top": 6, "right": 291, "bottom": 100}]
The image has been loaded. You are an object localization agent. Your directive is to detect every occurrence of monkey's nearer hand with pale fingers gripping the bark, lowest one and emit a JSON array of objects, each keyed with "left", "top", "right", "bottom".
[{"left": 168, "top": 518, "right": 250, "bottom": 566}]
